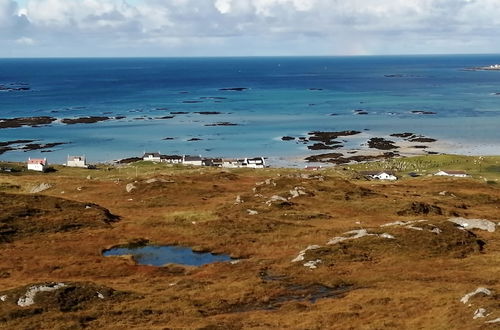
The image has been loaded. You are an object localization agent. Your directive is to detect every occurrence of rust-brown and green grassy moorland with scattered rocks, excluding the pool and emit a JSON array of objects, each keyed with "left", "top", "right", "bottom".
[{"left": 0, "top": 155, "right": 500, "bottom": 329}]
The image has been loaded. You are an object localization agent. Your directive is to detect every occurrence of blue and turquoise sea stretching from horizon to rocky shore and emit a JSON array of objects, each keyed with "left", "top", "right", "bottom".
[{"left": 0, "top": 55, "right": 500, "bottom": 164}]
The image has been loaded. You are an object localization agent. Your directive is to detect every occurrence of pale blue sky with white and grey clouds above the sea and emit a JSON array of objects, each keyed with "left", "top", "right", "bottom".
[{"left": 0, "top": 0, "right": 500, "bottom": 57}]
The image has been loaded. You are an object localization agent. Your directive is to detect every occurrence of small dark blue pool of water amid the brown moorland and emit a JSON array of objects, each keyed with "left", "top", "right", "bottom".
[{"left": 103, "top": 245, "right": 232, "bottom": 267}]
